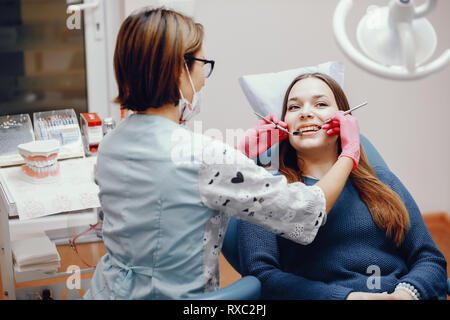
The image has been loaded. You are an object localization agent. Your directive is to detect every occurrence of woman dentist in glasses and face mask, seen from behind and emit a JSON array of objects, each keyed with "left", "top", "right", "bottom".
[{"left": 84, "top": 8, "right": 359, "bottom": 299}]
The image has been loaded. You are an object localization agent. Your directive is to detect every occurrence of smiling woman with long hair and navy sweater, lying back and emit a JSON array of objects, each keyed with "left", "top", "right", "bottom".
[{"left": 238, "top": 73, "right": 447, "bottom": 300}]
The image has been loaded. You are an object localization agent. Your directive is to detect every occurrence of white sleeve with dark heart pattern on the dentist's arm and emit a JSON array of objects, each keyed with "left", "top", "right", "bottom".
[{"left": 198, "top": 138, "right": 326, "bottom": 245}]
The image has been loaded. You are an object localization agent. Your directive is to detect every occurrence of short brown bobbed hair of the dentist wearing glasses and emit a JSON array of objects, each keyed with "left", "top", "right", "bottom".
[{"left": 114, "top": 8, "right": 204, "bottom": 111}]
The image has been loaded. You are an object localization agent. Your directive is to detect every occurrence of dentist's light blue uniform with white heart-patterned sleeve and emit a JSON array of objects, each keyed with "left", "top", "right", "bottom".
[{"left": 84, "top": 114, "right": 326, "bottom": 299}]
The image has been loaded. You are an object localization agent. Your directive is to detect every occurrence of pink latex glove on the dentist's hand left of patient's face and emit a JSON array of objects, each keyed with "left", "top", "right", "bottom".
[{"left": 236, "top": 113, "right": 289, "bottom": 159}]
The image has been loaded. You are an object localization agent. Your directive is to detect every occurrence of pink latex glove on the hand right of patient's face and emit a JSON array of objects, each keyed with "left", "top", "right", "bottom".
[{"left": 322, "top": 111, "right": 360, "bottom": 171}]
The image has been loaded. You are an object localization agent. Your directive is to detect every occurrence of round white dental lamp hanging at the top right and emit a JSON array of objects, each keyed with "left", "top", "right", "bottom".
[{"left": 333, "top": 0, "right": 450, "bottom": 80}]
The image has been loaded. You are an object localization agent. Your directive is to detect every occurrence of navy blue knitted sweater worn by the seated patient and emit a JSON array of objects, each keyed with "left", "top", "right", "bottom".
[{"left": 238, "top": 168, "right": 447, "bottom": 300}]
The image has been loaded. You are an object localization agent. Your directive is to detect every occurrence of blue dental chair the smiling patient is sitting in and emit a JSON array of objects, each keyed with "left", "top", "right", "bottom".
[{"left": 192, "top": 135, "right": 450, "bottom": 300}]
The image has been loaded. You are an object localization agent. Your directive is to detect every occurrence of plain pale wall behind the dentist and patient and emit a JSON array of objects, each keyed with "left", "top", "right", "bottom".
[{"left": 121, "top": 0, "right": 450, "bottom": 213}]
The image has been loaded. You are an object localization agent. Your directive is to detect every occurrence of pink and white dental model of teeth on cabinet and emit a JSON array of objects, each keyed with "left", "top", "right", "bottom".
[{"left": 17, "top": 139, "right": 59, "bottom": 183}]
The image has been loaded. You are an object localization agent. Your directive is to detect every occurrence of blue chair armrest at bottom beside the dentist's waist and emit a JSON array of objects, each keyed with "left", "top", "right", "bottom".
[{"left": 190, "top": 276, "right": 261, "bottom": 300}]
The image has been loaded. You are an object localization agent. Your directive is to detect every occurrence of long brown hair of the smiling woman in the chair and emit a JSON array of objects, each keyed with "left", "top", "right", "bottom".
[{"left": 280, "top": 73, "right": 409, "bottom": 246}]
